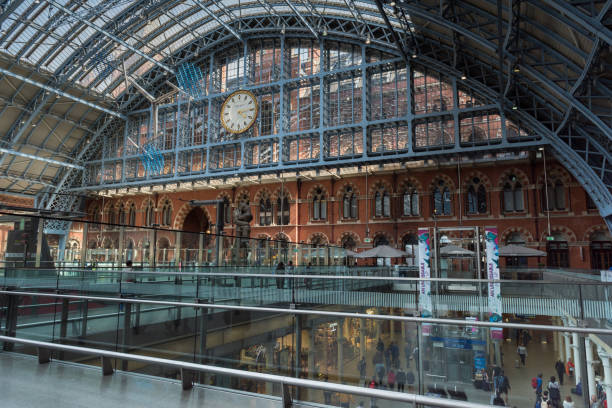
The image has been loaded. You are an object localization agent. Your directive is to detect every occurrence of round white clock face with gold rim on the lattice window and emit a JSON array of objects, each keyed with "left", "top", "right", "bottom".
[{"left": 221, "top": 91, "right": 258, "bottom": 133}]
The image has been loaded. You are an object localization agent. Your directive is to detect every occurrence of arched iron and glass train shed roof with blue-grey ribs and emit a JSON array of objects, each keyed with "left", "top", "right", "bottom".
[{"left": 0, "top": 0, "right": 612, "bottom": 233}]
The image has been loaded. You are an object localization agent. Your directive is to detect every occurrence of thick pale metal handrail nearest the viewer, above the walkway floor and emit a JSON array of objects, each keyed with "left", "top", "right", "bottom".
[{"left": 0, "top": 336, "right": 491, "bottom": 408}]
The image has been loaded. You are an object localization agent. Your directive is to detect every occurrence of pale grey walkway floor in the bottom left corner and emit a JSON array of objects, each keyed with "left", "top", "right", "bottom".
[{"left": 0, "top": 352, "right": 312, "bottom": 408}]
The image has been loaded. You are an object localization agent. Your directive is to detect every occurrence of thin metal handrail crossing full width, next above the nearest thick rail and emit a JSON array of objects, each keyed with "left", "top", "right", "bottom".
[{"left": 0, "top": 290, "right": 612, "bottom": 335}]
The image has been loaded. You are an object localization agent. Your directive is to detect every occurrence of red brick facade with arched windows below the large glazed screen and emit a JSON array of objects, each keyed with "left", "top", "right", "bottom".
[{"left": 83, "top": 158, "right": 609, "bottom": 268}]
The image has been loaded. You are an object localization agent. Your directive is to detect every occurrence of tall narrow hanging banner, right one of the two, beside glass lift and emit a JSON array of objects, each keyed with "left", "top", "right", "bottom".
[{"left": 485, "top": 227, "right": 503, "bottom": 340}]
